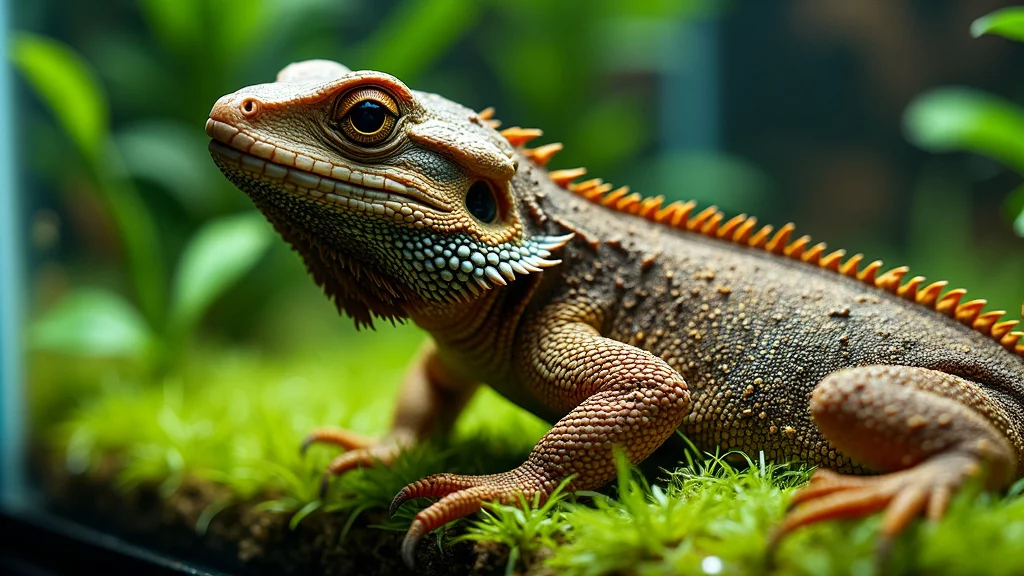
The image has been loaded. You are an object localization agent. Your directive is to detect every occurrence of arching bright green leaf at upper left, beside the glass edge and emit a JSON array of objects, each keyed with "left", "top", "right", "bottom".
[{"left": 10, "top": 32, "right": 109, "bottom": 160}]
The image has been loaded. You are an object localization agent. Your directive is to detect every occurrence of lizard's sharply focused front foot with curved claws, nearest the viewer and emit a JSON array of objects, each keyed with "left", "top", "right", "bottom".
[{"left": 391, "top": 465, "right": 557, "bottom": 568}]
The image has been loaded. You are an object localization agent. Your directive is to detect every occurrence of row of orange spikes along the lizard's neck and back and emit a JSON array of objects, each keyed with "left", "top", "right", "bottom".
[{"left": 480, "top": 117, "right": 1024, "bottom": 356}]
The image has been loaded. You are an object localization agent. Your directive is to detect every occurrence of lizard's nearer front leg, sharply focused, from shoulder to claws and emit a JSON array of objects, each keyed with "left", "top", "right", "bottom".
[{"left": 391, "top": 303, "right": 690, "bottom": 565}]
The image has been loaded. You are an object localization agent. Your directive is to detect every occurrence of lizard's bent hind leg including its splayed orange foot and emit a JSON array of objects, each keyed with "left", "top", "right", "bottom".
[{"left": 773, "top": 366, "right": 1019, "bottom": 556}]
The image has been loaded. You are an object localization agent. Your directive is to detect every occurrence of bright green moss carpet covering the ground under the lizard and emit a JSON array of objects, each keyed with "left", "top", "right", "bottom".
[{"left": 33, "top": 327, "right": 1024, "bottom": 575}]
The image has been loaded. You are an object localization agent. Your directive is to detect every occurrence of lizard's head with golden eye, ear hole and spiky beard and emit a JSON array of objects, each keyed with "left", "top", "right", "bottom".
[{"left": 206, "top": 60, "right": 568, "bottom": 325}]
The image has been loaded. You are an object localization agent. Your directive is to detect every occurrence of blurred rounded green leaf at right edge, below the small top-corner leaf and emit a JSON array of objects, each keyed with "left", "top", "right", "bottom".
[{"left": 903, "top": 88, "right": 1024, "bottom": 173}]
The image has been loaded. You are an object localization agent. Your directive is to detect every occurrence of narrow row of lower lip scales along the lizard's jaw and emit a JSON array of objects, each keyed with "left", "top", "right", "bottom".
[{"left": 210, "top": 139, "right": 447, "bottom": 215}]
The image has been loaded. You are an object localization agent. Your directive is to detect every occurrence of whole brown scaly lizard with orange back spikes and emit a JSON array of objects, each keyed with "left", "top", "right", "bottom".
[{"left": 207, "top": 60, "right": 1024, "bottom": 563}]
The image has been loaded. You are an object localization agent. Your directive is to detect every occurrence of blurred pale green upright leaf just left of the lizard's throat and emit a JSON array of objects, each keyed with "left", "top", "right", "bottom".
[{"left": 171, "top": 212, "right": 271, "bottom": 329}]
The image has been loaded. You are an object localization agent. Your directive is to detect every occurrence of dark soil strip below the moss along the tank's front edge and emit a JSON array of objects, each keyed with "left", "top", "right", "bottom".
[{"left": 36, "top": 450, "right": 520, "bottom": 575}]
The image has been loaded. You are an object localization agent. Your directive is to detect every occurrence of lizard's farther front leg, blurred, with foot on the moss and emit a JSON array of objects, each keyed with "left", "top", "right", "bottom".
[{"left": 302, "top": 341, "right": 477, "bottom": 491}]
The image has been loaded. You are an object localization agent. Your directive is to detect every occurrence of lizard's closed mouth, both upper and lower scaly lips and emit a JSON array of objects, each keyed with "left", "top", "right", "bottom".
[{"left": 206, "top": 118, "right": 449, "bottom": 214}]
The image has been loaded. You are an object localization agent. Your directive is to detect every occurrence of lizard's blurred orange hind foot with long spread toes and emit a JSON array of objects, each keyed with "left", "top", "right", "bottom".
[{"left": 770, "top": 454, "right": 981, "bottom": 561}]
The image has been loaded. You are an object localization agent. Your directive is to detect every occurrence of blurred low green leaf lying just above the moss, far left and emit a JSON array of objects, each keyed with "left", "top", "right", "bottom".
[{"left": 29, "top": 288, "right": 154, "bottom": 358}]
